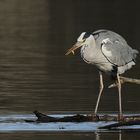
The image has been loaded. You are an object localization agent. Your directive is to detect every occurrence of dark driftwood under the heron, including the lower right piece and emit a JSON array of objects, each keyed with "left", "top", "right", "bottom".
[{"left": 25, "top": 111, "right": 140, "bottom": 130}]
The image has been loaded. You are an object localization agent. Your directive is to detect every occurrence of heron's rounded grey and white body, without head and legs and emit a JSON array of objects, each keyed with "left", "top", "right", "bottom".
[{"left": 81, "top": 30, "right": 137, "bottom": 77}]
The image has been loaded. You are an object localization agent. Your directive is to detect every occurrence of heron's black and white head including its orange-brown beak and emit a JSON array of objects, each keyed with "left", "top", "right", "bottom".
[{"left": 65, "top": 32, "right": 95, "bottom": 55}]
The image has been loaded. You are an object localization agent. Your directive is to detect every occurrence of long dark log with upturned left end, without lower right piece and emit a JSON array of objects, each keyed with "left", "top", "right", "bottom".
[{"left": 25, "top": 111, "right": 140, "bottom": 123}]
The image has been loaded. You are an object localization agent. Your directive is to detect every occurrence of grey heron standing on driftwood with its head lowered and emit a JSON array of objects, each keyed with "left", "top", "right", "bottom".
[{"left": 66, "top": 29, "right": 138, "bottom": 120}]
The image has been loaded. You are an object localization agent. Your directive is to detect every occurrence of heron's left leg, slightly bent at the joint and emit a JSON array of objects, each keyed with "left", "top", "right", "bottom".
[{"left": 94, "top": 71, "right": 104, "bottom": 116}]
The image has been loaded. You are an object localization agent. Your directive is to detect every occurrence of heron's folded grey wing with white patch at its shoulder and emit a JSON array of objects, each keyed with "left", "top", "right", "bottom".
[{"left": 101, "top": 38, "right": 138, "bottom": 66}]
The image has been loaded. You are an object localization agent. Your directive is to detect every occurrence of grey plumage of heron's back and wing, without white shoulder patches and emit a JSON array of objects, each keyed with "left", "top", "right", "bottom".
[{"left": 92, "top": 30, "right": 138, "bottom": 66}]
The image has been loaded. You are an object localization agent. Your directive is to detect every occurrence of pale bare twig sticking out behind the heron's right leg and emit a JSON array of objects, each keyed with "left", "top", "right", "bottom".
[{"left": 108, "top": 76, "right": 140, "bottom": 88}]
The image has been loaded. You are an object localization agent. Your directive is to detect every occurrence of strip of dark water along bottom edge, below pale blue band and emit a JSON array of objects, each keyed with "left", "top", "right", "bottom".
[{"left": 0, "top": 132, "right": 140, "bottom": 140}]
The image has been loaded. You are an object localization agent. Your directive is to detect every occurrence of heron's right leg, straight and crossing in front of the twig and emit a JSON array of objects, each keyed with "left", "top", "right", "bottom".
[{"left": 117, "top": 74, "right": 123, "bottom": 120}]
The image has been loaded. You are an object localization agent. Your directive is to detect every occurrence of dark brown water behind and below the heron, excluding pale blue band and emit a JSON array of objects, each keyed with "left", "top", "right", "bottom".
[{"left": 0, "top": 0, "right": 140, "bottom": 140}]
